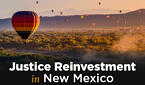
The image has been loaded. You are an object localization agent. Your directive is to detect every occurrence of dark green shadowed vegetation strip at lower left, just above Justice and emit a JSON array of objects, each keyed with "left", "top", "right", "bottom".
[{"left": 0, "top": 48, "right": 79, "bottom": 71}]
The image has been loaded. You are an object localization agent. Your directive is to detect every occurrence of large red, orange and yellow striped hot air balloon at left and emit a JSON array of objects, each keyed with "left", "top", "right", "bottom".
[{"left": 11, "top": 11, "right": 39, "bottom": 40}]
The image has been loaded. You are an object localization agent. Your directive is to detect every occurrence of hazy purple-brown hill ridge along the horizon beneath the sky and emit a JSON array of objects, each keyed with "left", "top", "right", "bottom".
[{"left": 0, "top": 9, "right": 145, "bottom": 29}]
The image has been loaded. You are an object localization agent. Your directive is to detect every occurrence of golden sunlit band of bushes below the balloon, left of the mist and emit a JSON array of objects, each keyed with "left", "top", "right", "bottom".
[{"left": 0, "top": 31, "right": 120, "bottom": 51}]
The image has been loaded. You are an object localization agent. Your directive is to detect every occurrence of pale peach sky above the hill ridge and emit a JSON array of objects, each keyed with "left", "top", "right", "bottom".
[{"left": 0, "top": 0, "right": 145, "bottom": 19}]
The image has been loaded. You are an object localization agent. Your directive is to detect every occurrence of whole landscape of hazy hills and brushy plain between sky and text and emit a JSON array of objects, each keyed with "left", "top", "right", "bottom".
[{"left": 0, "top": 9, "right": 145, "bottom": 69}]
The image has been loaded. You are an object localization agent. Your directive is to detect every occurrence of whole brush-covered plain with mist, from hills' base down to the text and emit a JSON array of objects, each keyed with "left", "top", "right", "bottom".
[{"left": 0, "top": 27, "right": 145, "bottom": 68}]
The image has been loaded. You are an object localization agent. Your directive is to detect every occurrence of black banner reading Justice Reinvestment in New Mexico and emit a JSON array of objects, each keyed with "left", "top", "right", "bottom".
[{"left": 0, "top": 62, "right": 145, "bottom": 85}]
